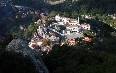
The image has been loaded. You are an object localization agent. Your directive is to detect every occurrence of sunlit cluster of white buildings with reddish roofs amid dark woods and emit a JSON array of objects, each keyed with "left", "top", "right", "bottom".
[{"left": 29, "top": 14, "right": 91, "bottom": 53}]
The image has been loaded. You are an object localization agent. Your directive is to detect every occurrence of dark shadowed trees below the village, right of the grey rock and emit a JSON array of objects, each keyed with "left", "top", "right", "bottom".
[{"left": 43, "top": 38, "right": 116, "bottom": 73}]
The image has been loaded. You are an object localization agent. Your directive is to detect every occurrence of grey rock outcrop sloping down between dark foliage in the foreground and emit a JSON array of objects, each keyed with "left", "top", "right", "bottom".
[{"left": 6, "top": 38, "right": 49, "bottom": 73}]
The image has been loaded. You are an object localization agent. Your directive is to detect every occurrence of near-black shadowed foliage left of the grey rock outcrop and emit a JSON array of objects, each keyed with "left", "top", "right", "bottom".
[{"left": 0, "top": 50, "right": 36, "bottom": 73}]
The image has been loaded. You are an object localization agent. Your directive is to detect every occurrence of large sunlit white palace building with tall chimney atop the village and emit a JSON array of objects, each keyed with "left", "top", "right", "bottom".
[{"left": 55, "top": 15, "right": 90, "bottom": 35}]
